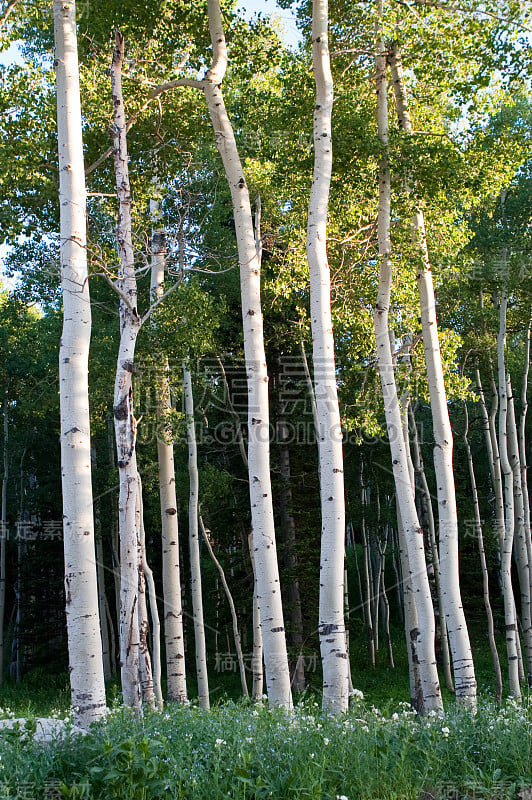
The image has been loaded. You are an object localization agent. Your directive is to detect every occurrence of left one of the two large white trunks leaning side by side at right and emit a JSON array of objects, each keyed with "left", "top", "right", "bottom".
[{"left": 373, "top": 21, "right": 442, "bottom": 711}]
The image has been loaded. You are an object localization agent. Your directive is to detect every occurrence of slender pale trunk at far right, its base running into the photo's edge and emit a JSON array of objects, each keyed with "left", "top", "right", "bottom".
[{"left": 506, "top": 375, "right": 532, "bottom": 684}]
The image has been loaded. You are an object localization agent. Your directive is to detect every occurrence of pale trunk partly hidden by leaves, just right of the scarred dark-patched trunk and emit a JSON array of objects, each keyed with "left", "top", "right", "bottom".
[{"left": 150, "top": 201, "right": 187, "bottom": 703}]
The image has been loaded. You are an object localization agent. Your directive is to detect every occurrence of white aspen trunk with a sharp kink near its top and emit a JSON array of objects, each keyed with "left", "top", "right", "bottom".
[{"left": 202, "top": 0, "right": 292, "bottom": 707}]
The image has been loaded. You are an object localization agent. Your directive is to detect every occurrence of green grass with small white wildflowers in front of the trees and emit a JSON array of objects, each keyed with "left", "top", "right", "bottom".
[{"left": 0, "top": 697, "right": 532, "bottom": 800}]
